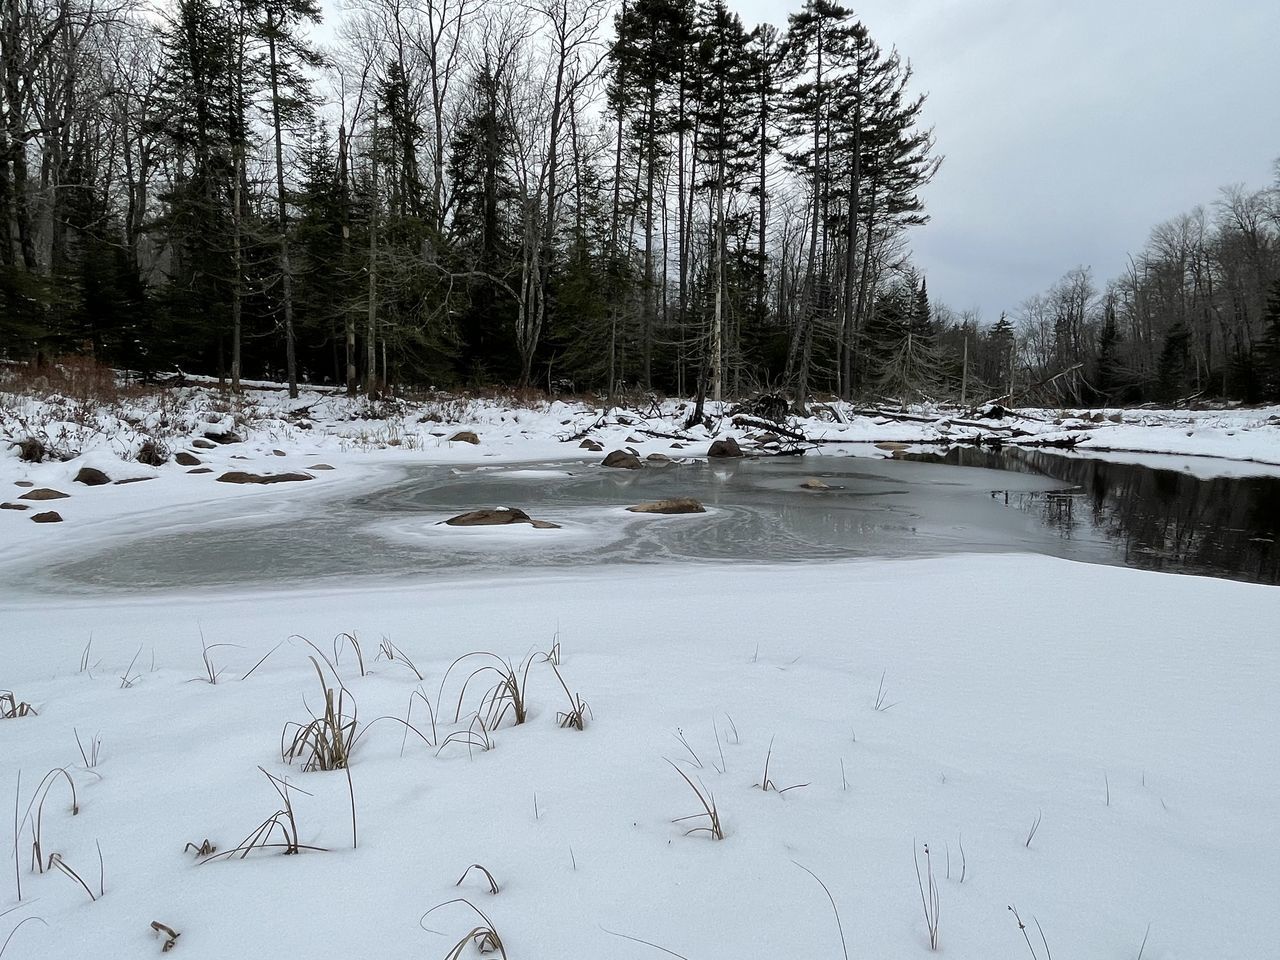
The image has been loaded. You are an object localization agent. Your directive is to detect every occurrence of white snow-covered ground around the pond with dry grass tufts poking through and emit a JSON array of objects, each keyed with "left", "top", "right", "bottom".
[{"left": 0, "top": 378, "right": 1280, "bottom": 960}]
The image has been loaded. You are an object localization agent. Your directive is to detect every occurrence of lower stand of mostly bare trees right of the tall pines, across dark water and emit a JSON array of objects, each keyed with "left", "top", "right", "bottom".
[{"left": 1016, "top": 172, "right": 1280, "bottom": 403}]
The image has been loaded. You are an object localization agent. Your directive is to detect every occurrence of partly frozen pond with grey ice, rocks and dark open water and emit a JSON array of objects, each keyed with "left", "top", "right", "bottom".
[{"left": 32, "top": 449, "right": 1280, "bottom": 591}]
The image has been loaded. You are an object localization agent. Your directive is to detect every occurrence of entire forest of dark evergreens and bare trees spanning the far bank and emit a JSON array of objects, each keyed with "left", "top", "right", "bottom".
[{"left": 0, "top": 0, "right": 1280, "bottom": 410}]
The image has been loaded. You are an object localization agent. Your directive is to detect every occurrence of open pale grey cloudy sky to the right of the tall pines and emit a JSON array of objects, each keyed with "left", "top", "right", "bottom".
[{"left": 731, "top": 0, "right": 1280, "bottom": 321}]
